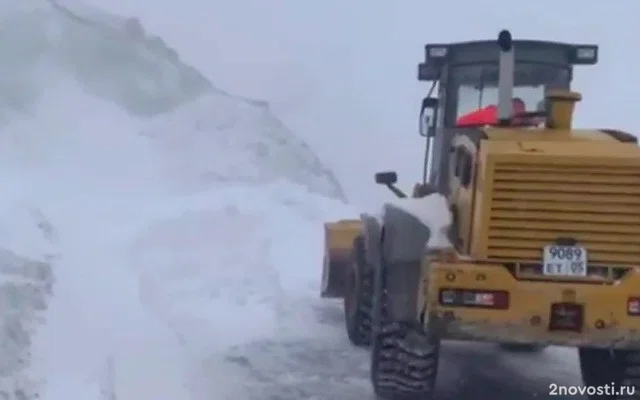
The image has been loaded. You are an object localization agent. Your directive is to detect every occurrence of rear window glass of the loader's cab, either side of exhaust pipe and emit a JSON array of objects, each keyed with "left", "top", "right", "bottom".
[{"left": 453, "top": 63, "right": 569, "bottom": 118}]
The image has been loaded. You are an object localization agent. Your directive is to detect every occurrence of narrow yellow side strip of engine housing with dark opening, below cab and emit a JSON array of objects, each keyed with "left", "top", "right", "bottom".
[{"left": 449, "top": 135, "right": 476, "bottom": 254}]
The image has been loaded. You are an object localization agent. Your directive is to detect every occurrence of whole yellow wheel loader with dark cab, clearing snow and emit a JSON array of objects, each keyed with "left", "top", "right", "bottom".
[{"left": 322, "top": 30, "right": 640, "bottom": 400}]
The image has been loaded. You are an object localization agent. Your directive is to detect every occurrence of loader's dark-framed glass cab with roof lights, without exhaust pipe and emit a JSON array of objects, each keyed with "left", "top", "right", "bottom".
[{"left": 418, "top": 39, "right": 598, "bottom": 193}]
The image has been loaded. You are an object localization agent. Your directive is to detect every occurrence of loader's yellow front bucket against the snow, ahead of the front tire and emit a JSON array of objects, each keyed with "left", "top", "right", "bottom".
[{"left": 320, "top": 219, "right": 362, "bottom": 298}]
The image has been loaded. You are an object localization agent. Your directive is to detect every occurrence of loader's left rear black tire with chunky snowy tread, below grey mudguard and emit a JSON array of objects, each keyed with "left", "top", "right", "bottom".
[{"left": 370, "top": 244, "right": 440, "bottom": 400}]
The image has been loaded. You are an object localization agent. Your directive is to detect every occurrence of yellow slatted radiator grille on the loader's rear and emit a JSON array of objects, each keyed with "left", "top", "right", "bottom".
[{"left": 487, "top": 161, "right": 640, "bottom": 266}]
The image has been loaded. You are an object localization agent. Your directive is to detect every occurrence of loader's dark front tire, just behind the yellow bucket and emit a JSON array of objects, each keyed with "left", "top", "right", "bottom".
[{"left": 343, "top": 236, "right": 373, "bottom": 347}]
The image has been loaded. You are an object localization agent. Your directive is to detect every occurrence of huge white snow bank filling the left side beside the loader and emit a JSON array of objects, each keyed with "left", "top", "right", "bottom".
[{"left": 0, "top": 2, "right": 346, "bottom": 400}]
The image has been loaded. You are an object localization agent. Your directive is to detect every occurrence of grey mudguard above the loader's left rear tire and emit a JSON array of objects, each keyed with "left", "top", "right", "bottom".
[{"left": 376, "top": 204, "right": 431, "bottom": 321}]
